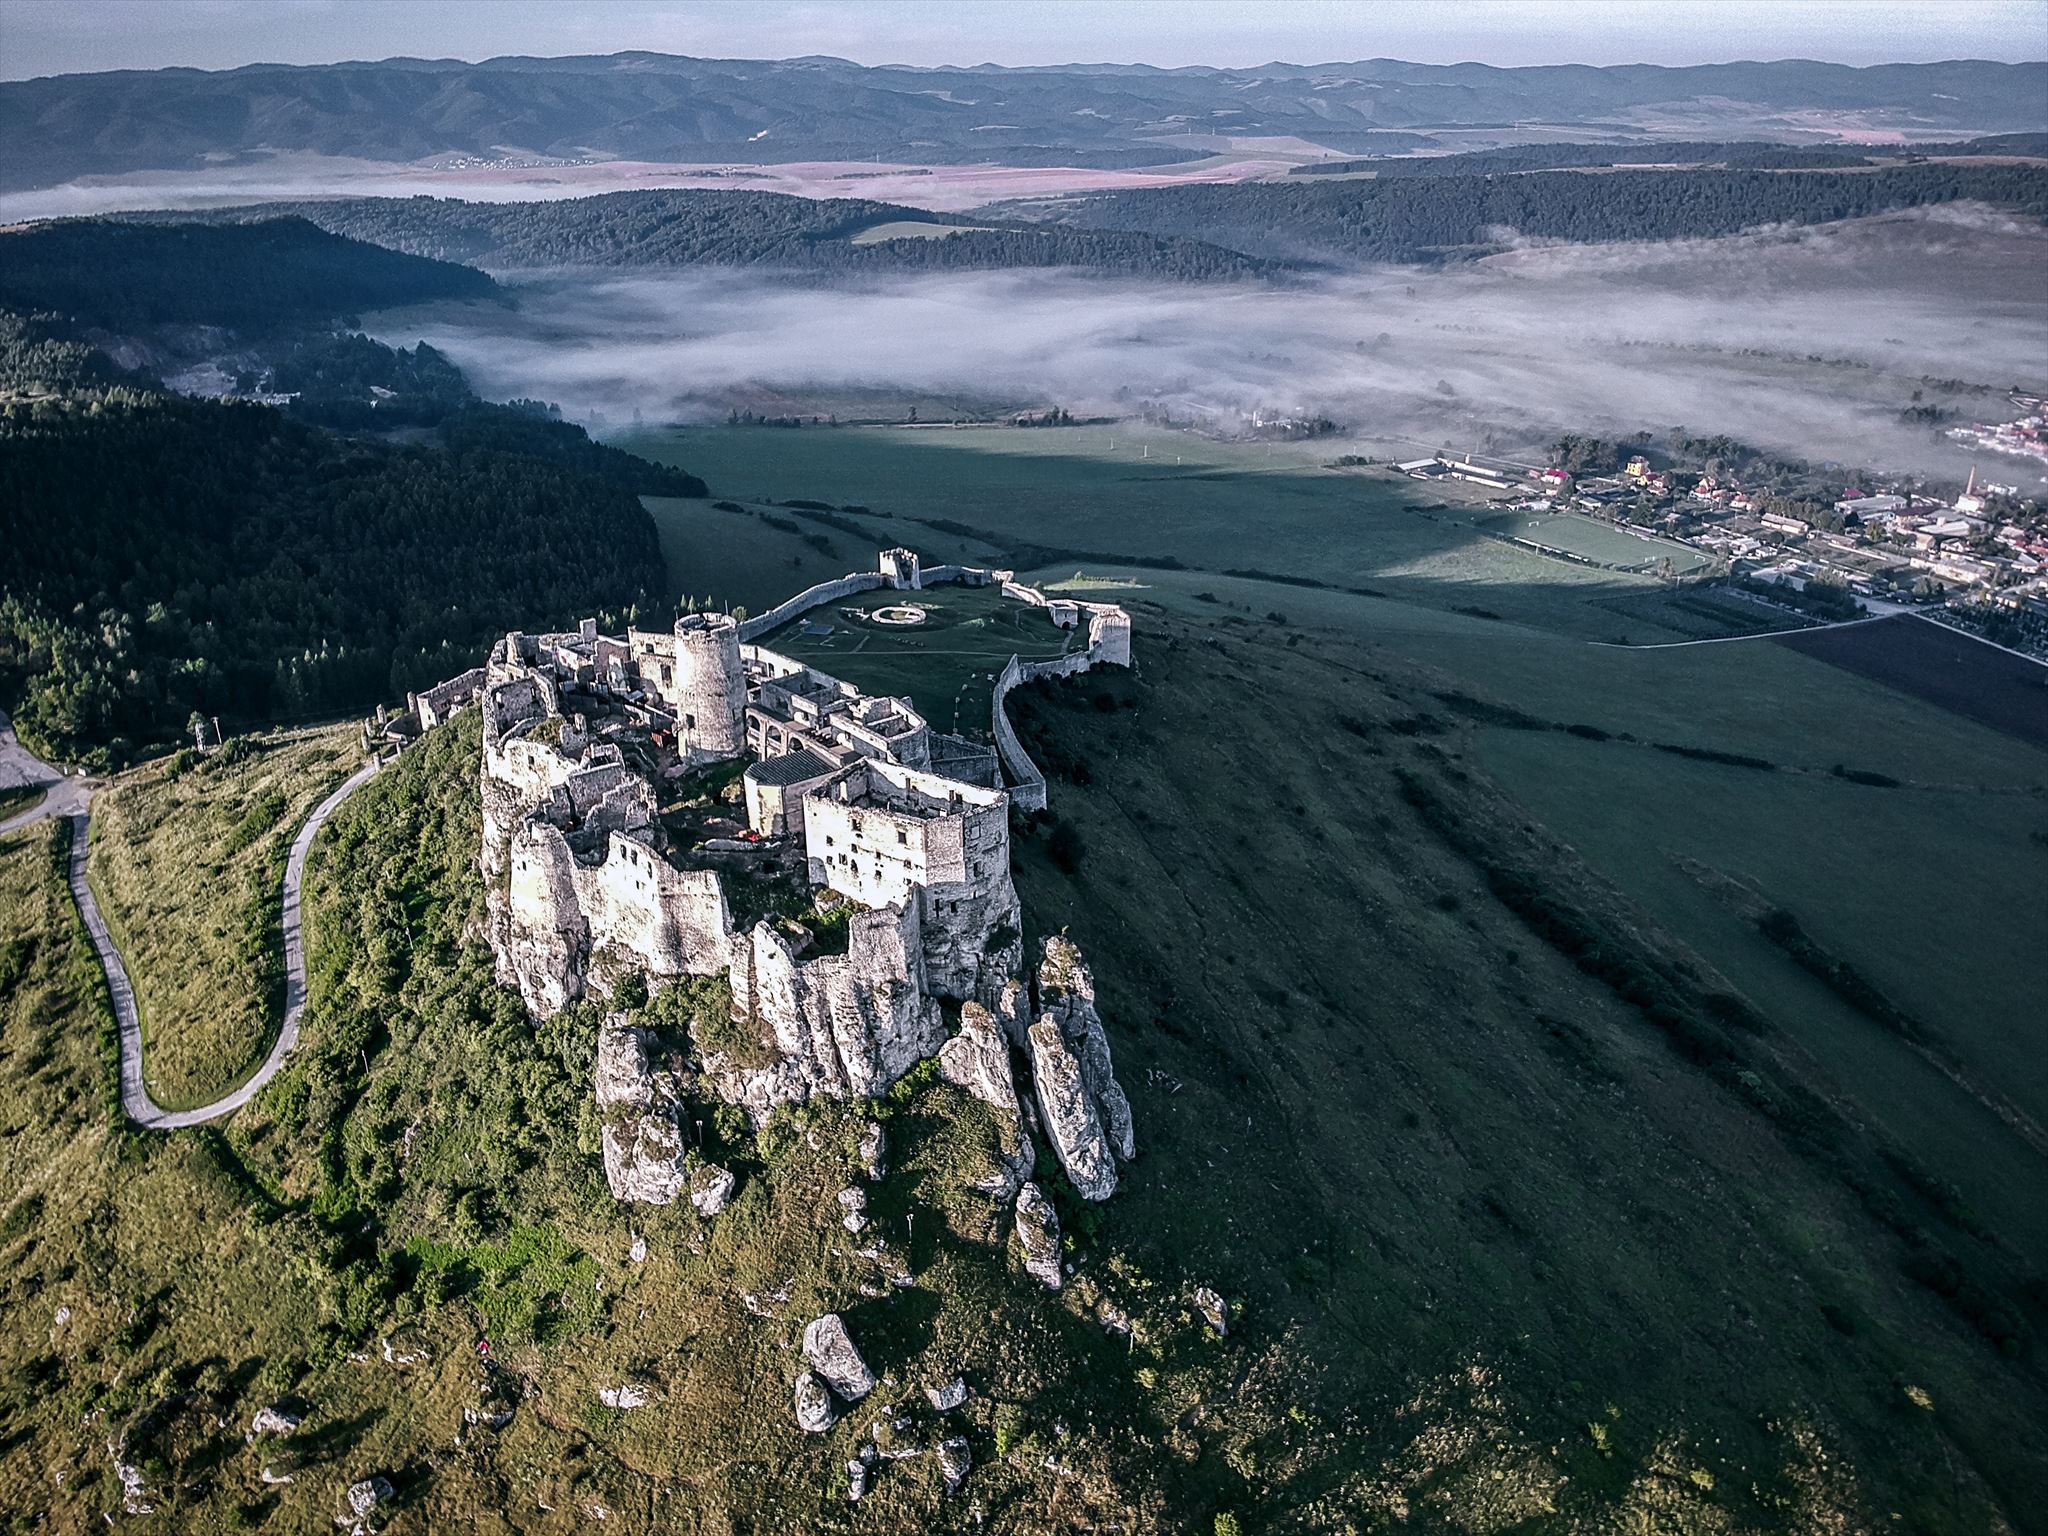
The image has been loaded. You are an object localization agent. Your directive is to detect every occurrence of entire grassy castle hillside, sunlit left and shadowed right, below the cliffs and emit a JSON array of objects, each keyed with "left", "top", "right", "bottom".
[{"left": 0, "top": 610, "right": 2048, "bottom": 1532}]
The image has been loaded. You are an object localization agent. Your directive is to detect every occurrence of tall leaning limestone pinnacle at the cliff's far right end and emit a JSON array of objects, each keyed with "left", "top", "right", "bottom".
[{"left": 1026, "top": 938, "right": 1137, "bottom": 1200}]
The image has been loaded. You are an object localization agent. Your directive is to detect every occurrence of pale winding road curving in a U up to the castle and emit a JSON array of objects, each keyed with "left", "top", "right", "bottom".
[{"left": 0, "top": 723, "right": 379, "bottom": 1130}]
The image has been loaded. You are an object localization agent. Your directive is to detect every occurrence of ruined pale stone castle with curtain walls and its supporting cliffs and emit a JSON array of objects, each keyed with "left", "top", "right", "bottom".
[{"left": 466, "top": 549, "right": 1133, "bottom": 1198}]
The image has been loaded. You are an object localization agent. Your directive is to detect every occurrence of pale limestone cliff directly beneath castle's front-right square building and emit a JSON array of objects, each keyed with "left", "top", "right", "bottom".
[{"left": 705, "top": 905, "right": 946, "bottom": 1120}]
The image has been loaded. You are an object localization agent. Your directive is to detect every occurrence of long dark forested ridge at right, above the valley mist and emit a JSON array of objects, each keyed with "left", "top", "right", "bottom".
[{"left": 1071, "top": 164, "right": 2048, "bottom": 262}]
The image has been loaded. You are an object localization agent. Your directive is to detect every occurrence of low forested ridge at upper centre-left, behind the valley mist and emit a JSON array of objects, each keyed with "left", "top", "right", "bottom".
[{"left": 148, "top": 190, "right": 1268, "bottom": 279}]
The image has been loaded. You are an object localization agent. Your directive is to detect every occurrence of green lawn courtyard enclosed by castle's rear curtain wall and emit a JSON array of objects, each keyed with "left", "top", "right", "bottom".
[{"left": 762, "top": 586, "right": 1087, "bottom": 737}]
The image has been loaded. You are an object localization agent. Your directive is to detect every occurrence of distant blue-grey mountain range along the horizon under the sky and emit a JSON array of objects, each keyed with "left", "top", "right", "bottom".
[{"left": 0, "top": 53, "right": 2048, "bottom": 190}]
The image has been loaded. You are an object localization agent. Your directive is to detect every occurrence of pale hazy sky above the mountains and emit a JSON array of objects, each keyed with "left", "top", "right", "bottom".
[{"left": 0, "top": 0, "right": 2048, "bottom": 80}]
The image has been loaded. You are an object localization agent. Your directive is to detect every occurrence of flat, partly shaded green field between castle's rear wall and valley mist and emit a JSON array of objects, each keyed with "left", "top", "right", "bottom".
[{"left": 614, "top": 424, "right": 1655, "bottom": 639}]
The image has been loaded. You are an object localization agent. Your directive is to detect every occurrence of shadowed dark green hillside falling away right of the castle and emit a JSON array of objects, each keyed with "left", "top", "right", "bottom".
[{"left": 1003, "top": 614, "right": 2048, "bottom": 1530}]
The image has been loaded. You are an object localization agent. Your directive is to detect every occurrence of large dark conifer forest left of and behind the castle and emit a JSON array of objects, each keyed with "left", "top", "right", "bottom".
[{"left": 0, "top": 370, "right": 671, "bottom": 758}]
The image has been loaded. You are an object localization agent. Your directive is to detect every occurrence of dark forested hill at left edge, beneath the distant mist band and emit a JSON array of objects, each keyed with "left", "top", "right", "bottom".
[{"left": 0, "top": 219, "right": 498, "bottom": 330}]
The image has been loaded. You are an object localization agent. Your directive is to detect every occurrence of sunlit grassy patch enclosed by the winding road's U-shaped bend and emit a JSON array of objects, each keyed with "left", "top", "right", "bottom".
[{"left": 90, "top": 723, "right": 358, "bottom": 1108}]
